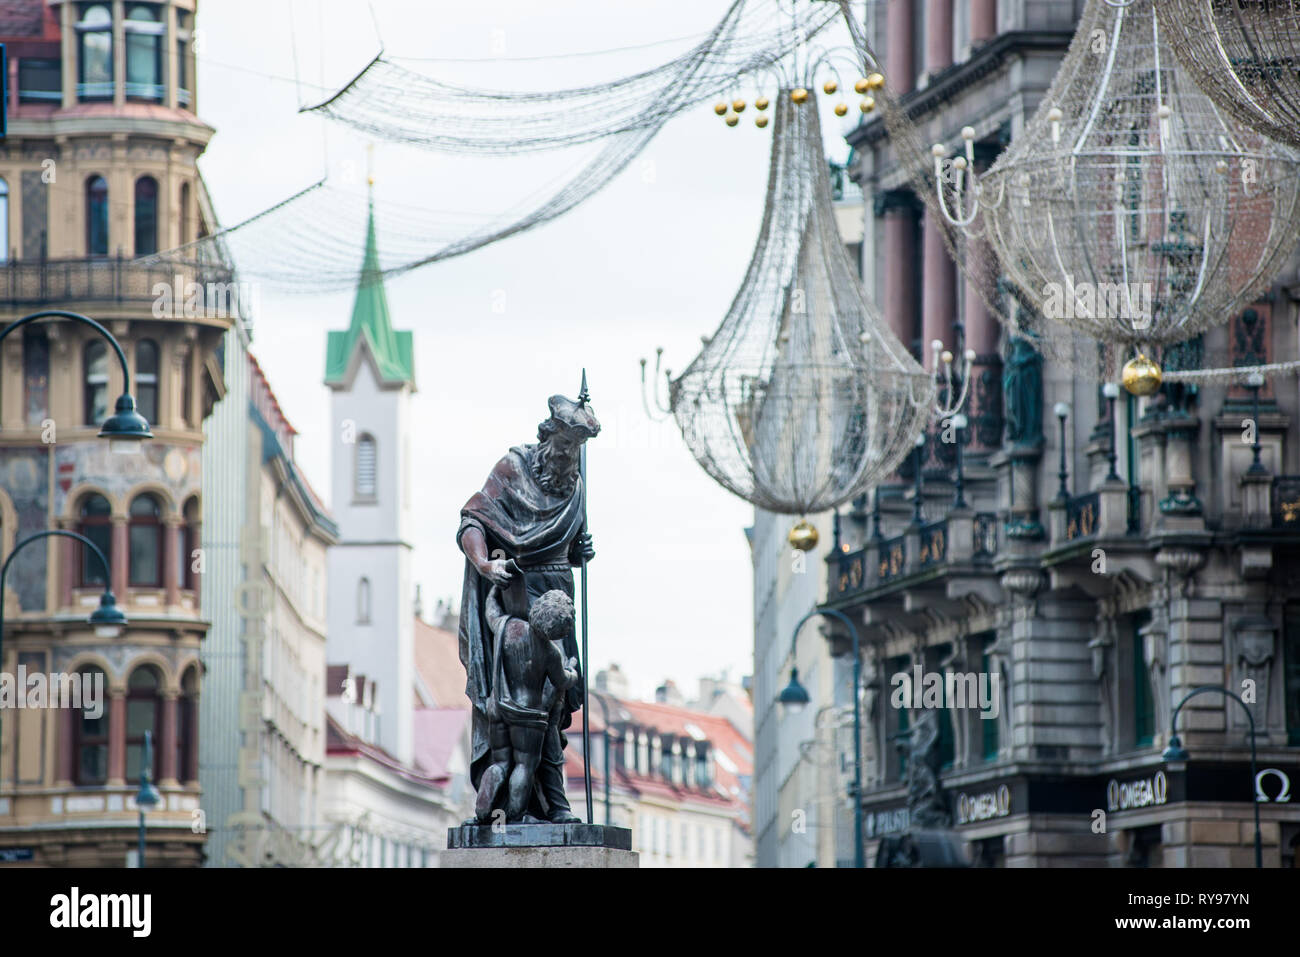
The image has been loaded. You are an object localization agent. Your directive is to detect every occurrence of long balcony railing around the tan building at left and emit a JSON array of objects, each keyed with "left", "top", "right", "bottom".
[{"left": 0, "top": 259, "right": 238, "bottom": 315}]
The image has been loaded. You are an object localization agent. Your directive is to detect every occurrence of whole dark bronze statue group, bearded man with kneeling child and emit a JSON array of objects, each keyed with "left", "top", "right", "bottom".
[{"left": 456, "top": 395, "right": 601, "bottom": 823}]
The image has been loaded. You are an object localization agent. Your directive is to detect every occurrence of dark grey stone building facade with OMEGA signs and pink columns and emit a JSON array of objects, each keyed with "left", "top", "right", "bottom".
[{"left": 826, "top": 0, "right": 1300, "bottom": 867}]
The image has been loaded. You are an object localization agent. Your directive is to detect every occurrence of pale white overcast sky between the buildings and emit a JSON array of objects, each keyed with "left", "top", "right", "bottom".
[{"left": 198, "top": 0, "right": 857, "bottom": 697}]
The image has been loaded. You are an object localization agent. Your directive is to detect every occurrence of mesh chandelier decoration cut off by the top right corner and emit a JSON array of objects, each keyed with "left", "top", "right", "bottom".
[{"left": 1156, "top": 0, "right": 1300, "bottom": 148}]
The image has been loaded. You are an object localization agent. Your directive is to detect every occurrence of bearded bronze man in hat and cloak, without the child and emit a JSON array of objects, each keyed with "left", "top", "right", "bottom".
[{"left": 456, "top": 395, "right": 601, "bottom": 823}]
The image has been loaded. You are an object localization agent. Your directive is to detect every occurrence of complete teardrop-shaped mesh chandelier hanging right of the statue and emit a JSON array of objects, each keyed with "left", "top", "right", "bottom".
[{"left": 642, "top": 82, "right": 935, "bottom": 522}]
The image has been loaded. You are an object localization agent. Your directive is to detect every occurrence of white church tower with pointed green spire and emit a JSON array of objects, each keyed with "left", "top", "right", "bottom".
[{"left": 325, "top": 200, "right": 415, "bottom": 763}]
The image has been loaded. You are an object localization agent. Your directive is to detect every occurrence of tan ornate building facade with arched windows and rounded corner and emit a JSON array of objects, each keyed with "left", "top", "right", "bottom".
[{"left": 0, "top": 0, "right": 228, "bottom": 866}]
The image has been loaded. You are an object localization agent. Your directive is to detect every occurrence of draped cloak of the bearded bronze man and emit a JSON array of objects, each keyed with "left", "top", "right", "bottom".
[{"left": 456, "top": 445, "right": 584, "bottom": 788}]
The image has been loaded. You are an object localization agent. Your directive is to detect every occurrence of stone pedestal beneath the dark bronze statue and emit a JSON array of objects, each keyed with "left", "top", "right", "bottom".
[{"left": 441, "top": 824, "right": 640, "bottom": 867}]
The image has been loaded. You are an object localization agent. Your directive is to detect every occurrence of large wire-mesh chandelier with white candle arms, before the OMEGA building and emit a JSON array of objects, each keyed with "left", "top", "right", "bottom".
[{"left": 933, "top": 0, "right": 1300, "bottom": 382}]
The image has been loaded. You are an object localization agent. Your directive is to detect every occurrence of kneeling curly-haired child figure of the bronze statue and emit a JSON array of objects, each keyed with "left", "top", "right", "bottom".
[{"left": 475, "top": 575, "right": 579, "bottom": 824}]
